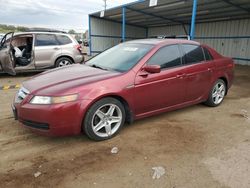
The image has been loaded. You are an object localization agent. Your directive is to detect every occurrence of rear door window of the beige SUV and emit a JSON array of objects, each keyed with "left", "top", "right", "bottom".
[{"left": 35, "top": 34, "right": 58, "bottom": 46}]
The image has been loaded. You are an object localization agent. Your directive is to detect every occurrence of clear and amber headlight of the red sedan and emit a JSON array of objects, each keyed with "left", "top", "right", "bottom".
[{"left": 30, "top": 94, "right": 78, "bottom": 104}]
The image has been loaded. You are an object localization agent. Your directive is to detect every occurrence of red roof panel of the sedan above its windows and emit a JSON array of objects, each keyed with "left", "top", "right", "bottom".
[{"left": 127, "top": 39, "right": 200, "bottom": 46}]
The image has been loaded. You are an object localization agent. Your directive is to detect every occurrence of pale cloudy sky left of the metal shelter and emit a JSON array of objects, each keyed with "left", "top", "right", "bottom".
[{"left": 0, "top": 0, "right": 135, "bottom": 32}]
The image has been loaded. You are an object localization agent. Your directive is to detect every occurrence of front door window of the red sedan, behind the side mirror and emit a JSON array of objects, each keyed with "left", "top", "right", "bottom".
[{"left": 148, "top": 45, "right": 181, "bottom": 69}]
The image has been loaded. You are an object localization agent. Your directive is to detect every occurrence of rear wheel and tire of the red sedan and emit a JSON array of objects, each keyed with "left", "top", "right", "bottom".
[{"left": 205, "top": 79, "right": 227, "bottom": 107}]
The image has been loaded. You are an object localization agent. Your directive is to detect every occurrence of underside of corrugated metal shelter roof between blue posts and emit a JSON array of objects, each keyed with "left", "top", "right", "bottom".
[{"left": 91, "top": 0, "right": 250, "bottom": 27}]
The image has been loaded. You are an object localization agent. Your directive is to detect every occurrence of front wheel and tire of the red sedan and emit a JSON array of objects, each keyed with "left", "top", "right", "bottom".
[{"left": 82, "top": 97, "right": 125, "bottom": 141}]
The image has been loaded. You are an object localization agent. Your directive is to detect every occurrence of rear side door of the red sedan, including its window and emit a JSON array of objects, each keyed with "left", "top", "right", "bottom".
[{"left": 181, "top": 44, "right": 214, "bottom": 101}]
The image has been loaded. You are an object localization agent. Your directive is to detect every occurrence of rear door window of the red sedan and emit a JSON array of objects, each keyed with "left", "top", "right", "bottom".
[{"left": 182, "top": 44, "right": 205, "bottom": 64}]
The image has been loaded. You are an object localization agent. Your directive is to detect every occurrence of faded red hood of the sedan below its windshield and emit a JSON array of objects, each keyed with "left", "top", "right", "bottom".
[{"left": 23, "top": 65, "right": 121, "bottom": 95}]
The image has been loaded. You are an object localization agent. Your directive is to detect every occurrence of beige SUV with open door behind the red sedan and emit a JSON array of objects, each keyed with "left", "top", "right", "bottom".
[{"left": 0, "top": 31, "right": 84, "bottom": 75}]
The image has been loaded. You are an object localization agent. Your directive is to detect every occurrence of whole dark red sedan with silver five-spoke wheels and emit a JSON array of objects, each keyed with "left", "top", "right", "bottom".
[{"left": 12, "top": 39, "right": 234, "bottom": 140}]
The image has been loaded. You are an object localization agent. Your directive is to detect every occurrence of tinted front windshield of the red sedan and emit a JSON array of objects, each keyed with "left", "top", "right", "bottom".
[{"left": 86, "top": 43, "right": 153, "bottom": 72}]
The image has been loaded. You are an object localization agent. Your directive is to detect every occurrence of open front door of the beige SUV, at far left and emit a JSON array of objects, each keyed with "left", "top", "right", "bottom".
[{"left": 0, "top": 32, "right": 16, "bottom": 75}]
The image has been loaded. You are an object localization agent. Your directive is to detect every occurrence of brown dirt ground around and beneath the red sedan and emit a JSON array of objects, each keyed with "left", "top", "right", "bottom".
[{"left": 0, "top": 66, "right": 250, "bottom": 188}]
